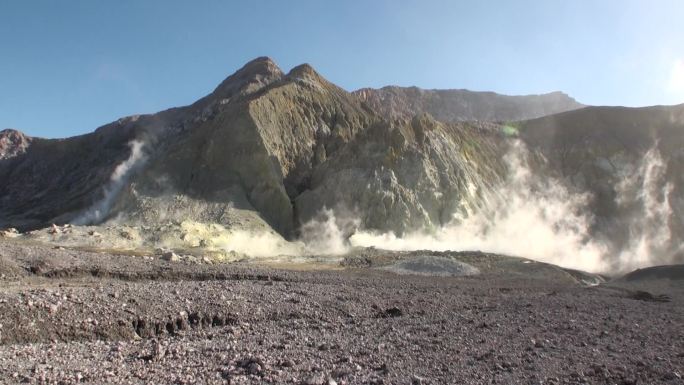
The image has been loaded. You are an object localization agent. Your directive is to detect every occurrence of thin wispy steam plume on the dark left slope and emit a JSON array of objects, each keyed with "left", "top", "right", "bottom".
[{"left": 72, "top": 140, "right": 147, "bottom": 225}]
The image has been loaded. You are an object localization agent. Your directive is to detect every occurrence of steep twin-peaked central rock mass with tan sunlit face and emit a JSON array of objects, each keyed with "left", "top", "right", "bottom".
[{"left": 116, "top": 58, "right": 380, "bottom": 235}]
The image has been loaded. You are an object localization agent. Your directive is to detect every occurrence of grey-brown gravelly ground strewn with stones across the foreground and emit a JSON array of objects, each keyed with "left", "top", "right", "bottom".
[{"left": 0, "top": 240, "right": 684, "bottom": 384}]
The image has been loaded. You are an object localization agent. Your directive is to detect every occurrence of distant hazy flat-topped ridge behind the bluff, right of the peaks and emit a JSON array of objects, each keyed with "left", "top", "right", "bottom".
[{"left": 354, "top": 86, "right": 584, "bottom": 122}]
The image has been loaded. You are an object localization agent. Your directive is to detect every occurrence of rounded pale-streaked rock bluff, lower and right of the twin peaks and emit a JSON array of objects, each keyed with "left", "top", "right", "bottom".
[{"left": 295, "top": 114, "right": 506, "bottom": 234}]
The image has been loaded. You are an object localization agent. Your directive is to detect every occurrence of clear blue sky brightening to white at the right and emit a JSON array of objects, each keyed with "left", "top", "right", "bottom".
[{"left": 0, "top": 0, "right": 684, "bottom": 137}]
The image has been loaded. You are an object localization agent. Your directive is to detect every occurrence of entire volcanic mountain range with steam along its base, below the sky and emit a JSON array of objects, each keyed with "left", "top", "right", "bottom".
[{"left": 0, "top": 57, "right": 684, "bottom": 267}]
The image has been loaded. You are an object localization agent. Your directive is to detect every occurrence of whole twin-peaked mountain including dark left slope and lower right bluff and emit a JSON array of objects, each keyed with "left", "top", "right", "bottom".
[{"left": 0, "top": 58, "right": 502, "bottom": 236}]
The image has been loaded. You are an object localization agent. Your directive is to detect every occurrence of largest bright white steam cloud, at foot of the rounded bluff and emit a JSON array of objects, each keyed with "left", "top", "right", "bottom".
[{"left": 351, "top": 141, "right": 607, "bottom": 271}]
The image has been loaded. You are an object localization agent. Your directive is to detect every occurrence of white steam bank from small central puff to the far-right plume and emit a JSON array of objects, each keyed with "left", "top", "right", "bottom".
[{"left": 296, "top": 141, "right": 673, "bottom": 273}]
